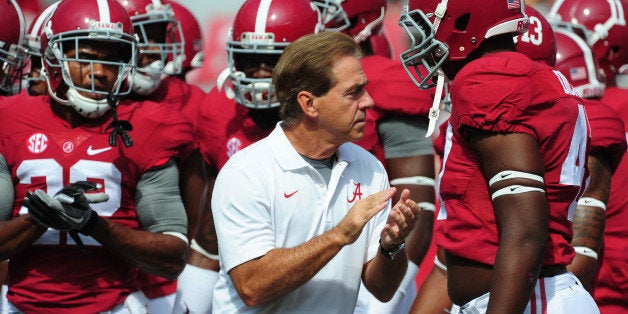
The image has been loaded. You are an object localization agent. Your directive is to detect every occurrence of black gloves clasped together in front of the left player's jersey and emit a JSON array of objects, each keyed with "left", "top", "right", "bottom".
[{"left": 22, "top": 181, "right": 109, "bottom": 235}]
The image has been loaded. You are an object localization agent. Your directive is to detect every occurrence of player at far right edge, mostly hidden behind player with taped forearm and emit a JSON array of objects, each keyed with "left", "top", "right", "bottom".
[{"left": 549, "top": 0, "right": 628, "bottom": 313}]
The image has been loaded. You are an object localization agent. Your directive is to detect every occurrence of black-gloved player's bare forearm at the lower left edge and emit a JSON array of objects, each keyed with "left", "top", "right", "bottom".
[{"left": 0, "top": 214, "right": 46, "bottom": 261}]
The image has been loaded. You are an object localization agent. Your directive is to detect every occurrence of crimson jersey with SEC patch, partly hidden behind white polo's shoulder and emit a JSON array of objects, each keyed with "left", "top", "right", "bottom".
[{"left": 195, "top": 87, "right": 273, "bottom": 170}]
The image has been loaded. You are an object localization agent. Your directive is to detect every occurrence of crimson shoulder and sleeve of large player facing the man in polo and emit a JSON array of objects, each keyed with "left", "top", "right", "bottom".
[{"left": 451, "top": 53, "right": 580, "bottom": 137}]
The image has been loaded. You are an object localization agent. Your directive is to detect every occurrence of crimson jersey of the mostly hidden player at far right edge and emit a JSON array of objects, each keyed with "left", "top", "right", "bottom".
[{"left": 593, "top": 87, "right": 628, "bottom": 313}]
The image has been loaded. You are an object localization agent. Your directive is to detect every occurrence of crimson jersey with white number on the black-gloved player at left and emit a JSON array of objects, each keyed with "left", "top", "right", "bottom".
[{"left": 0, "top": 95, "right": 193, "bottom": 313}]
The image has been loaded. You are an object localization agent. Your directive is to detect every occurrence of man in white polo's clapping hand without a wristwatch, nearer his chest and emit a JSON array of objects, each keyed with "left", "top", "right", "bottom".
[{"left": 337, "top": 188, "right": 397, "bottom": 243}]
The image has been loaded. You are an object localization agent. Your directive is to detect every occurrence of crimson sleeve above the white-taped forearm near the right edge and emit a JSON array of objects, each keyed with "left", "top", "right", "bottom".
[{"left": 584, "top": 99, "right": 626, "bottom": 172}]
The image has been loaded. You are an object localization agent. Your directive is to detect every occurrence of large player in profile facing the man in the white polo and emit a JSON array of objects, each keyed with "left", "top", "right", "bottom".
[{"left": 399, "top": 0, "right": 598, "bottom": 313}]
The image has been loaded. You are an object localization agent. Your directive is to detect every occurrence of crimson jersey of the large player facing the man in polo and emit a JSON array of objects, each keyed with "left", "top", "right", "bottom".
[{"left": 435, "top": 52, "right": 590, "bottom": 265}]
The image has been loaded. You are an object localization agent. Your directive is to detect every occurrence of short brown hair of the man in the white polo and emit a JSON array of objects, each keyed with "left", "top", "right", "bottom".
[{"left": 273, "top": 32, "right": 362, "bottom": 125}]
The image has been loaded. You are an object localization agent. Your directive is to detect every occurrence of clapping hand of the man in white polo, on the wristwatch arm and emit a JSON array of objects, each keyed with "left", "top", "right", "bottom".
[{"left": 381, "top": 189, "right": 421, "bottom": 249}]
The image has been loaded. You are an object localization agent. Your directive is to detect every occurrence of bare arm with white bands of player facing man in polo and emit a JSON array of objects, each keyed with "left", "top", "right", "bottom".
[{"left": 468, "top": 131, "right": 549, "bottom": 313}]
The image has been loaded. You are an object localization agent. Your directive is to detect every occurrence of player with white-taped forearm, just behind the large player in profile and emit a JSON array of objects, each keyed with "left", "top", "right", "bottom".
[{"left": 555, "top": 28, "right": 626, "bottom": 288}]
